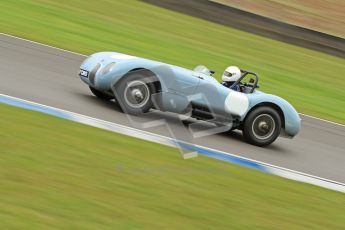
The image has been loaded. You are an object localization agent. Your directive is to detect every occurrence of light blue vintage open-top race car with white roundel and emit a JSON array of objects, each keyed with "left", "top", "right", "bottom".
[{"left": 79, "top": 52, "right": 301, "bottom": 146}]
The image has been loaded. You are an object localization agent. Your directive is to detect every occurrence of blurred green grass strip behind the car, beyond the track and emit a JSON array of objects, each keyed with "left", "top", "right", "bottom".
[{"left": 0, "top": 0, "right": 345, "bottom": 123}]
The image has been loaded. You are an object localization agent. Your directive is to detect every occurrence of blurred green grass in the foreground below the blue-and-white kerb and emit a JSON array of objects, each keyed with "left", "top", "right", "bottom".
[{"left": 0, "top": 104, "right": 345, "bottom": 230}]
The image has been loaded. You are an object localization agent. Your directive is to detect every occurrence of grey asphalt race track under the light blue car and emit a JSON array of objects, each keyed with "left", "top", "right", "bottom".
[{"left": 0, "top": 34, "right": 345, "bottom": 183}]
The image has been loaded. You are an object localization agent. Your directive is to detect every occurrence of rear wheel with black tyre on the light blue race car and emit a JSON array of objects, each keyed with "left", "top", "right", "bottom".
[{"left": 243, "top": 106, "right": 282, "bottom": 146}]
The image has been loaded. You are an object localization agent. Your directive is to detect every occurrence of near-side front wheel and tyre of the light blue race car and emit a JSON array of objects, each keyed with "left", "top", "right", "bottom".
[{"left": 113, "top": 71, "right": 155, "bottom": 115}]
